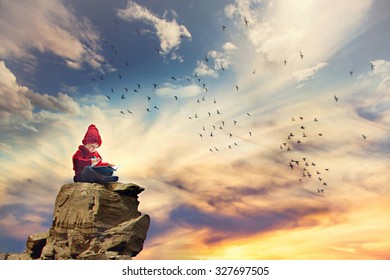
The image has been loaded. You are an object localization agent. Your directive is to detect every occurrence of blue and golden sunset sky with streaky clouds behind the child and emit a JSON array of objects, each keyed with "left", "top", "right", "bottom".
[{"left": 0, "top": 0, "right": 390, "bottom": 260}]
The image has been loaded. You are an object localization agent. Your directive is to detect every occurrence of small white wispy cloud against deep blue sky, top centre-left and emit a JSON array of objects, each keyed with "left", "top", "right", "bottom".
[{"left": 117, "top": 1, "right": 191, "bottom": 61}]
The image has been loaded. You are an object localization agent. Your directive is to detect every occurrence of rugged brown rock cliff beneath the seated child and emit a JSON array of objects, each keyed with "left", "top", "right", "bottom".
[{"left": 0, "top": 183, "right": 150, "bottom": 260}]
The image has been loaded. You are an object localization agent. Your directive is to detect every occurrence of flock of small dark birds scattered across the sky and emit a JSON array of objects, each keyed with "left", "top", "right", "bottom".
[{"left": 88, "top": 15, "right": 374, "bottom": 194}]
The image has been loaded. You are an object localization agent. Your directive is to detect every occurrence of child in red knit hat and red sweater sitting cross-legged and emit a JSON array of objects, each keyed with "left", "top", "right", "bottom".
[{"left": 72, "top": 124, "right": 118, "bottom": 183}]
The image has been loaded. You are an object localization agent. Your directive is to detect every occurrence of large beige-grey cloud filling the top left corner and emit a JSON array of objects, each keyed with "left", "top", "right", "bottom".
[{"left": 0, "top": 0, "right": 104, "bottom": 69}]
